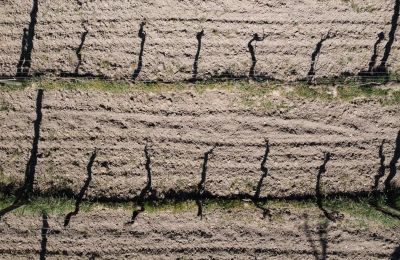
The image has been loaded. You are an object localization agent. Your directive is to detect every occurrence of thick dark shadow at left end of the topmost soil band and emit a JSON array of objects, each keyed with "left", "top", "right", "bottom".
[{"left": 16, "top": 0, "right": 39, "bottom": 77}]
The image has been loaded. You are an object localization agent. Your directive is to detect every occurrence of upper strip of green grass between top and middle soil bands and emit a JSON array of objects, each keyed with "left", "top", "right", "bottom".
[{"left": 0, "top": 78, "right": 400, "bottom": 106}]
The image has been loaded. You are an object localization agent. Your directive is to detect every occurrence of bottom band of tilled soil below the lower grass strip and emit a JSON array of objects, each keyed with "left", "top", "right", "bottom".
[{"left": 0, "top": 207, "right": 400, "bottom": 259}]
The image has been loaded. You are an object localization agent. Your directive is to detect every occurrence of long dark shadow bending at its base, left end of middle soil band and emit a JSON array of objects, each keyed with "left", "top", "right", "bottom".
[{"left": 0, "top": 89, "right": 43, "bottom": 219}]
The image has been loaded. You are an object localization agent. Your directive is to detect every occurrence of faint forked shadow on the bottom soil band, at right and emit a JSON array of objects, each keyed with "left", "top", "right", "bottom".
[{"left": 304, "top": 215, "right": 329, "bottom": 260}]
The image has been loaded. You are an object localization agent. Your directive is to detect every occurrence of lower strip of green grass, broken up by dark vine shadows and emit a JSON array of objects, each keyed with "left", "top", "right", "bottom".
[{"left": 0, "top": 192, "right": 400, "bottom": 227}]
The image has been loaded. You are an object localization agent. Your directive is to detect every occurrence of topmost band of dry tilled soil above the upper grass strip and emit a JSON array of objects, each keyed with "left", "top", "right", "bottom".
[{"left": 0, "top": 0, "right": 400, "bottom": 81}]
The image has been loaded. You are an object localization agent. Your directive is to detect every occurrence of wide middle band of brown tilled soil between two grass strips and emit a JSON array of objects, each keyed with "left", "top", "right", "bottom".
[{"left": 0, "top": 90, "right": 400, "bottom": 201}]
